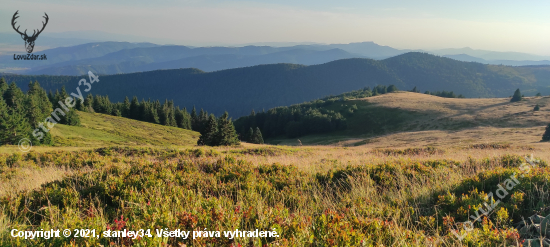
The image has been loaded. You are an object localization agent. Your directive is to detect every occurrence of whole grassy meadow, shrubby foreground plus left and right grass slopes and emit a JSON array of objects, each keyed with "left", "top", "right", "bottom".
[{"left": 0, "top": 93, "right": 550, "bottom": 246}]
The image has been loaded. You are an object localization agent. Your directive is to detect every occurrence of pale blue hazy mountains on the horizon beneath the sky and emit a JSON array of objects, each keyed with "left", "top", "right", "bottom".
[{"left": 0, "top": 39, "right": 550, "bottom": 75}]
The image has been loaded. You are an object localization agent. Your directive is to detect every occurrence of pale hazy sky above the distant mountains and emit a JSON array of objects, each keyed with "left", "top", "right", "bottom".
[{"left": 0, "top": 0, "right": 550, "bottom": 55}]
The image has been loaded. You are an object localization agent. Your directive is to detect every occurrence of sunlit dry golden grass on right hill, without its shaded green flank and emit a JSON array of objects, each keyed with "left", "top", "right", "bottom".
[{"left": 317, "top": 92, "right": 550, "bottom": 149}]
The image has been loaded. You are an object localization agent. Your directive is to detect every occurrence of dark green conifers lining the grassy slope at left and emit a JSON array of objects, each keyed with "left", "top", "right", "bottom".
[{"left": 0, "top": 78, "right": 242, "bottom": 146}]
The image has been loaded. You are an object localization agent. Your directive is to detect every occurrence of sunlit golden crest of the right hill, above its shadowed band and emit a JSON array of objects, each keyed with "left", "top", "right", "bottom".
[{"left": 363, "top": 92, "right": 550, "bottom": 128}]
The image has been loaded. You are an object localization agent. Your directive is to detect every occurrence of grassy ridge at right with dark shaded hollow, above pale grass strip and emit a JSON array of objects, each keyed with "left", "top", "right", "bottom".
[{"left": 266, "top": 92, "right": 550, "bottom": 145}]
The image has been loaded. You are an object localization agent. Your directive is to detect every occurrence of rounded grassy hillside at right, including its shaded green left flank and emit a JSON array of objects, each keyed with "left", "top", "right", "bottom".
[{"left": 268, "top": 92, "right": 550, "bottom": 147}]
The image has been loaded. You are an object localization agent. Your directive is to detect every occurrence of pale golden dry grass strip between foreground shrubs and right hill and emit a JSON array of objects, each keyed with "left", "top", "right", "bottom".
[{"left": 216, "top": 142, "right": 550, "bottom": 172}]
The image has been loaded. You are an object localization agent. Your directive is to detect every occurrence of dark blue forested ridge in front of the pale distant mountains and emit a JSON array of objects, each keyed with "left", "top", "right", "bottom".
[{"left": 3, "top": 52, "right": 550, "bottom": 117}]
